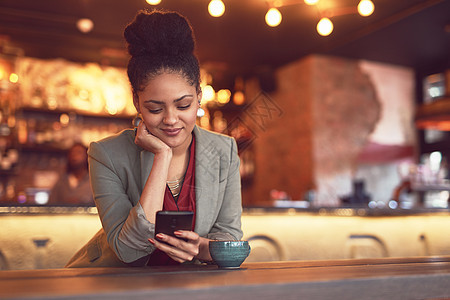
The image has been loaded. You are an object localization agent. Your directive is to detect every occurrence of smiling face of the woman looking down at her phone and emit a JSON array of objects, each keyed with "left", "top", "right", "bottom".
[{"left": 134, "top": 73, "right": 201, "bottom": 148}]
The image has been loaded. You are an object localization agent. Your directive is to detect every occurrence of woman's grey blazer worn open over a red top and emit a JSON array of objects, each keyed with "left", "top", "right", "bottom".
[{"left": 66, "top": 126, "right": 242, "bottom": 267}]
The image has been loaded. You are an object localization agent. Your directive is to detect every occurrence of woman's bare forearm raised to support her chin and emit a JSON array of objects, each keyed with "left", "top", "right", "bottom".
[{"left": 139, "top": 149, "right": 172, "bottom": 224}]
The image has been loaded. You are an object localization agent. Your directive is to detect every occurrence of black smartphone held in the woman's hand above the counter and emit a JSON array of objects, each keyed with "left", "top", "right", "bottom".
[{"left": 155, "top": 210, "right": 194, "bottom": 241}]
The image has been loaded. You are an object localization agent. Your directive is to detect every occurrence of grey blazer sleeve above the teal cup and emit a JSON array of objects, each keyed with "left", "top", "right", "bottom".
[{"left": 207, "top": 138, "right": 243, "bottom": 240}]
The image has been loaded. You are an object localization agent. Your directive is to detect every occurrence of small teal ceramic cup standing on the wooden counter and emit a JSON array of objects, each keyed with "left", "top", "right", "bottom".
[{"left": 209, "top": 241, "right": 251, "bottom": 269}]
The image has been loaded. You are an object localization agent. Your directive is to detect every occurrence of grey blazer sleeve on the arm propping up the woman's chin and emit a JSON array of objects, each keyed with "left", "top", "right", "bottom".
[{"left": 88, "top": 142, "right": 155, "bottom": 263}]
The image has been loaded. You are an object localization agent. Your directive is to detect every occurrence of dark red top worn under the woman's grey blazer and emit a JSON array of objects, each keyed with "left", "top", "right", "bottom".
[{"left": 147, "top": 135, "right": 195, "bottom": 266}]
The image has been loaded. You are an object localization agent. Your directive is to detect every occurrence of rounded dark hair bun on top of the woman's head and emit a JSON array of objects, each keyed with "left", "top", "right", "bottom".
[{"left": 124, "top": 11, "right": 195, "bottom": 56}]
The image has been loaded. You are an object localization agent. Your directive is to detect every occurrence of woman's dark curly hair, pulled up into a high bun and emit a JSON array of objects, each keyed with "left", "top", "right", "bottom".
[{"left": 124, "top": 10, "right": 200, "bottom": 94}]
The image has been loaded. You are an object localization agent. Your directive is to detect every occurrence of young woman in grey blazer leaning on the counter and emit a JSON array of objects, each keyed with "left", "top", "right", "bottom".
[{"left": 67, "top": 11, "right": 242, "bottom": 267}]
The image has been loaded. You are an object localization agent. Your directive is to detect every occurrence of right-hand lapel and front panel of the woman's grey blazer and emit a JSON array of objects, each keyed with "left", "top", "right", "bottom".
[{"left": 194, "top": 126, "right": 220, "bottom": 235}]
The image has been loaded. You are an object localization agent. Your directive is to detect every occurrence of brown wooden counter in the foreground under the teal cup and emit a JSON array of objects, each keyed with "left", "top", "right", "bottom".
[{"left": 0, "top": 256, "right": 450, "bottom": 300}]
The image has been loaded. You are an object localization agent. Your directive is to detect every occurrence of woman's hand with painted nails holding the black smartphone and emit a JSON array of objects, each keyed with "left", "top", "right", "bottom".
[{"left": 149, "top": 230, "right": 211, "bottom": 263}]
